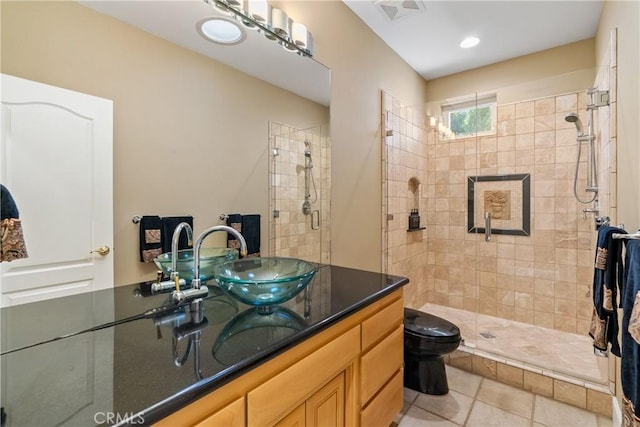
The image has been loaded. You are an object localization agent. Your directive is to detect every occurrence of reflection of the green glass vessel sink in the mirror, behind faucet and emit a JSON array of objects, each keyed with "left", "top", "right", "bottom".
[{"left": 153, "top": 248, "right": 238, "bottom": 284}]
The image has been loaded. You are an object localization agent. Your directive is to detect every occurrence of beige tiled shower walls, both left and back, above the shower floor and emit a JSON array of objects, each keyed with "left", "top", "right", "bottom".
[{"left": 382, "top": 85, "right": 615, "bottom": 334}]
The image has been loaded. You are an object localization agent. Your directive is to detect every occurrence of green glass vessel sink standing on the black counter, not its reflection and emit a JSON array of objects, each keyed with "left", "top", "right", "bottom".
[{"left": 213, "top": 257, "right": 317, "bottom": 307}]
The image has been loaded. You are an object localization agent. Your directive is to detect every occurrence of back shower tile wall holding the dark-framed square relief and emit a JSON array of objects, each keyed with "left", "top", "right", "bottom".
[{"left": 427, "top": 93, "right": 595, "bottom": 338}]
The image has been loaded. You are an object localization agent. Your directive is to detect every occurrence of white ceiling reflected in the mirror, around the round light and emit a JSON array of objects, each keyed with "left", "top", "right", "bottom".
[{"left": 79, "top": 0, "right": 330, "bottom": 107}]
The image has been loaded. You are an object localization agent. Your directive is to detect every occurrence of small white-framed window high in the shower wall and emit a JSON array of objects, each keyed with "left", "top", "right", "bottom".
[{"left": 441, "top": 94, "right": 496, "bottom": 139}]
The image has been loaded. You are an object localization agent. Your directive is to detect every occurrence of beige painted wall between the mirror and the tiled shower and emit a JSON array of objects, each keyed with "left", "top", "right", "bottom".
[{"left": 282, "top": 0, "right": 425, "bottom": 271}]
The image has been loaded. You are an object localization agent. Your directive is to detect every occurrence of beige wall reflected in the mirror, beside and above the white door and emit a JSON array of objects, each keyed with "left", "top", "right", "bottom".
[{"left": 1, "top": 1, "right": 328, "bottom": 285}]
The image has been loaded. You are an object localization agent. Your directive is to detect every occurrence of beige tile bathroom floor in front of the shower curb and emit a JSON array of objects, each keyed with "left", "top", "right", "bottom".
[{"left": 395, "top": 365, "right": 612, "bottom": 427}]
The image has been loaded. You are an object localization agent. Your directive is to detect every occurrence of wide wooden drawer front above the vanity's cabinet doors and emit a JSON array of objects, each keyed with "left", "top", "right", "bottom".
[{"left": 247, "top": 326, "right": 360, "bottom": 426}]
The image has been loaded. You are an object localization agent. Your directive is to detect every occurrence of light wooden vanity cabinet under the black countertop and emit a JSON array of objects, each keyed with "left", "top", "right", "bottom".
[{"left": 156, "top": 288, "right": 403, "bottom": 427}]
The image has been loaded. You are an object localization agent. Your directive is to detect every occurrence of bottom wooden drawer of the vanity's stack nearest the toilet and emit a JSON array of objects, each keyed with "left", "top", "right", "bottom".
[{"left": 360, "top": 369, "right": 403, "bottom": 427}]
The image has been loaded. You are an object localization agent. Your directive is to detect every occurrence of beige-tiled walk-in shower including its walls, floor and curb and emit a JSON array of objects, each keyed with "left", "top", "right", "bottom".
[{"left": 381, "top": 31, "right": 619, "bottom": 415}]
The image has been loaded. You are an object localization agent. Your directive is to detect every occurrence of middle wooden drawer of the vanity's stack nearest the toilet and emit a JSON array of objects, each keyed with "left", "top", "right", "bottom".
[{"left": 360, "top": 325, "right": 404, "bottom": 406}]
